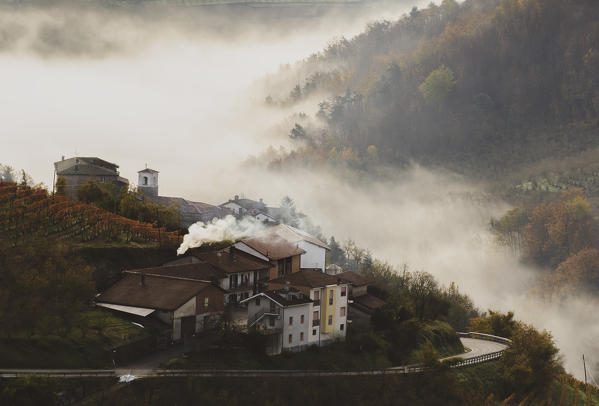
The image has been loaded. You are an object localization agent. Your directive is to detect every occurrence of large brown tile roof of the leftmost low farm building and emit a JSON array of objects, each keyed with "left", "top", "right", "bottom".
[{"left": 96, "top": 273, "right": 210, "bottom": 311}]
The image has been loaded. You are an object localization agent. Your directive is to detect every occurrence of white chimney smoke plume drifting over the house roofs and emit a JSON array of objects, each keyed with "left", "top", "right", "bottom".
[{"left": 177, "top": 215, "right": 264, "bottom": 255}]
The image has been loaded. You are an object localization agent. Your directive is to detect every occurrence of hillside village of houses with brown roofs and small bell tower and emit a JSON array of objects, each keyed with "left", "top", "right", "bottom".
[{"left": 54, "top": 157, "right": 385, "bottom": 355}]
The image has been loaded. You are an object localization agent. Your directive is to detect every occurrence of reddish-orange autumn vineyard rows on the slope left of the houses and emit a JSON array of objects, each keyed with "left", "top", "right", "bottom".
[{"left": 0, "top": 182, "right": 181, "bottom": 246}]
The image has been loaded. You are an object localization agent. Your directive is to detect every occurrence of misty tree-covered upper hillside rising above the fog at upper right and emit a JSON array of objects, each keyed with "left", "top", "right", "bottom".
[{"left": 268, "top": 0, "right": 599, "bottom": 176}]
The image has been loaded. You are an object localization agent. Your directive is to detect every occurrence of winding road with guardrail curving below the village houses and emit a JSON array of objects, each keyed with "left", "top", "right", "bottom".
[{"left": 0, "top": 333, "right": 507, "bottom": 381}]
